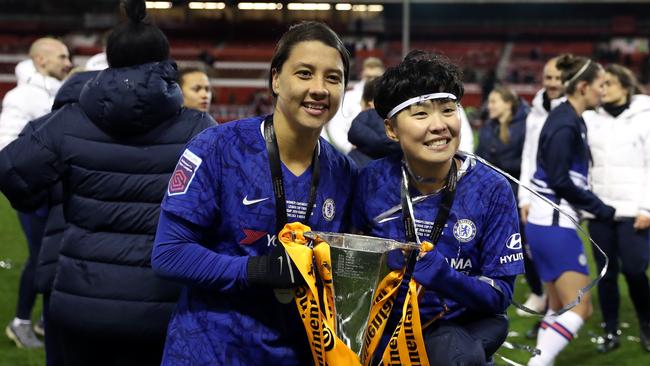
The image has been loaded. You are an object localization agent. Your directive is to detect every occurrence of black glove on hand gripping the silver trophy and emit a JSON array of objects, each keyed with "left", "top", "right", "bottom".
[{"left": 246, "top": 243, "right": 305, "bottom": 288}]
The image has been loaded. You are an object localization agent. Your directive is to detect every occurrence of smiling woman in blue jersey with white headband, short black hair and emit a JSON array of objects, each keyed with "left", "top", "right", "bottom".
[{"left": 352, "top": 51, "right": 523, "bottom": 365}]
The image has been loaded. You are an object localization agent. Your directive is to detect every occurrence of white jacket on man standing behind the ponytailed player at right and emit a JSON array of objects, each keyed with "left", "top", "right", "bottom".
[{"left": 517, "top": 89, "right": 566, "bottom": 207}]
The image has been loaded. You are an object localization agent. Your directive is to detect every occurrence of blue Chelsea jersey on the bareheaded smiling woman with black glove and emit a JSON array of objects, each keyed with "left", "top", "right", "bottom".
[{"left": 162, "top": 117, "right": 356, "bottom": 365}]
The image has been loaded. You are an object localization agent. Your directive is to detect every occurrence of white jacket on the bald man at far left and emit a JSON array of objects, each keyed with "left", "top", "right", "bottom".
[{"left": 0, "top": 72, "right": 62, "bottom": 150}]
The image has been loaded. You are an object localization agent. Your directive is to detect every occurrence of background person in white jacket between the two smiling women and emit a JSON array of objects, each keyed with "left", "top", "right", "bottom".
[{"left": 323, "top": 57, "right": 385, "bottom": 154}]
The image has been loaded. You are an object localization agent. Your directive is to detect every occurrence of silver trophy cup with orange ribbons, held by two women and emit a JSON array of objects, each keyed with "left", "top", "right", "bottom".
[{"left": 305, "top": 231, "right": 418, "bottom": 356}]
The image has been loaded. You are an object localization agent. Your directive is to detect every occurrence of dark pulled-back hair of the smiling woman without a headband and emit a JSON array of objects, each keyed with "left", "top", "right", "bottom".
[{"left": 269, "top": 21, "right": 350, "bottom": 98}]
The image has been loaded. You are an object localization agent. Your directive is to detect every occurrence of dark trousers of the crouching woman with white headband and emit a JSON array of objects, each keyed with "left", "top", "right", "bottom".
[{"left": 424, "top": 314, "right": 509, "bottom": 366}]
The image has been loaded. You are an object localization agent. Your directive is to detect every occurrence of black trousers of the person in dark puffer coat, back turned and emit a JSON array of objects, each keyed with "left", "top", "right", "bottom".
[{"left": 59, "top": 325, "right": 165, "bottom": 366}]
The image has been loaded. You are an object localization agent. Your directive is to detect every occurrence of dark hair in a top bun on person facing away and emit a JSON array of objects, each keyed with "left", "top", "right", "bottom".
[{"left": 106, "top": 0, "right": 169, "bottom": 67}]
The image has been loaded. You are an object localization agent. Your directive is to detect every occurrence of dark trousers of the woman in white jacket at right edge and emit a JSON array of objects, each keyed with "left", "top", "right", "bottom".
[{"left": 589, "top": 218, "right": 650, "bottom": 333}]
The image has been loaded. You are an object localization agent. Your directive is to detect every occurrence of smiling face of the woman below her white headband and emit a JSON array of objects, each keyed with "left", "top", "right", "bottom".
[{"left": 384, "top": 99, "right": 460, "bottom": 177}]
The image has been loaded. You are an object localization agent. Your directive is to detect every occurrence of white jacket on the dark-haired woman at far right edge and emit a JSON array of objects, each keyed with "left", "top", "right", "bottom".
[{"left": 582, "top": 95, "right": 650, "bottom": 218}]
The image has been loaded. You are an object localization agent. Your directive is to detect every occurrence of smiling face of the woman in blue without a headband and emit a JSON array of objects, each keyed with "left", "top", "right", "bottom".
[{"left": 272, "top": 41, "right": 344, "bottom": 130}]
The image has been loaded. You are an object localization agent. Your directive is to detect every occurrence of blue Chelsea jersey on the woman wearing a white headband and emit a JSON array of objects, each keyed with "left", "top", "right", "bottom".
[{"left": 352, "top": 157, "right": 524, "bottom": 322}]
